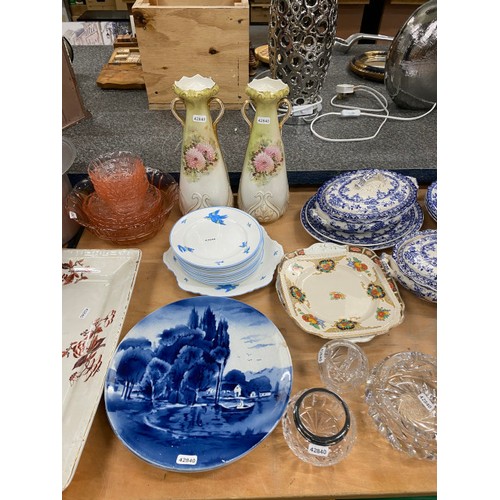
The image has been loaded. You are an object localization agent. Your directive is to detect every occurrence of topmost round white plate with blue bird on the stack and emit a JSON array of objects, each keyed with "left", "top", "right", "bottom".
[{"left": 170, "top": 207, "right": 263, "bottom": 269}]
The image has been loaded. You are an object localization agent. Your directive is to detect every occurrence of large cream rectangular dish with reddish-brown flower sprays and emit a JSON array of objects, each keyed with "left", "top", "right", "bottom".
[{"left": 62, "top": 249, "right": 141, "bottom": 490}]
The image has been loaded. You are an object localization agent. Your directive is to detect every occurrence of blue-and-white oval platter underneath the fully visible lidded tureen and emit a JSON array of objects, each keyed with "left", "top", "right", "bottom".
[{"left": 300, "top": 196, "right": 424, "bottom": 250}]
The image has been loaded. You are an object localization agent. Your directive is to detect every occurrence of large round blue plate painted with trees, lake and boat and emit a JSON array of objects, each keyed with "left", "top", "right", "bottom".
[{"left": 104, "top": 296, "right": 292, "bottom": 472}]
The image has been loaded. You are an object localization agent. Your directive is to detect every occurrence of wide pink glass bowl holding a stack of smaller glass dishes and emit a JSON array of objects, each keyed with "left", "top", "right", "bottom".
[{"left": 65, "top": 167, "right": 179, "bottom": 245}]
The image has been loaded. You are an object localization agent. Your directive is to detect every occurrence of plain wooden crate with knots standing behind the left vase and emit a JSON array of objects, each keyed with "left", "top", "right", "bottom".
[{"left": 132, "top": 0, "right": 250, "bottom": 109}]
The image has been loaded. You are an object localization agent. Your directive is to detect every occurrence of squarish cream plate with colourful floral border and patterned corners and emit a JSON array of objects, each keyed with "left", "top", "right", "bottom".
[{"left": 276, "top": 243, "right": 404, "bottom": 342}]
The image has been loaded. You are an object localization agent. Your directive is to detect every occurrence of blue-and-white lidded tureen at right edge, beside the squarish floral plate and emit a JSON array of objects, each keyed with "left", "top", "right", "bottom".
[{"left": 381, "top": 229, "right": 437, "bottom": 302}]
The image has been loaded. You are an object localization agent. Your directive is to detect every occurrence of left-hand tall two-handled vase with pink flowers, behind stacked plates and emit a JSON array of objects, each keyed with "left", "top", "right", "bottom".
[{"left": 171, "top": 75, "right": 233, "bottom": 214}]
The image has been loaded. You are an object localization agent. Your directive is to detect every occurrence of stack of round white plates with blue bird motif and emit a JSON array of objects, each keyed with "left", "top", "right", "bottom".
[{"left": 170, "top": 207, "right": 264, "bottom": 285}]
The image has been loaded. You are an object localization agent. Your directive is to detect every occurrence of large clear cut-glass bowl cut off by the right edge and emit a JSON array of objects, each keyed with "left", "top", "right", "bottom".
[{"left": 365, "top": 351, "right": 437, "bottom": 460}]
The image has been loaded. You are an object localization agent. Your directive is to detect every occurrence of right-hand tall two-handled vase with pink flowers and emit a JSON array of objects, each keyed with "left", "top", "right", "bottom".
[{"left": 238, "top": 77, "right": 292, "bottom": 223}]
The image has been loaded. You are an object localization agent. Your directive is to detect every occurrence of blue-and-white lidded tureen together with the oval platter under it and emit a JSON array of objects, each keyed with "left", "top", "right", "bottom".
[{"left": 301, "top": 169, "right": 424, "bottom": 250}]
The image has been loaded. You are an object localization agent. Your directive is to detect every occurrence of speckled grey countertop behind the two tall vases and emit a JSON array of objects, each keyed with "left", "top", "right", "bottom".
[{"left": 62, "top": 44, "right": 437, "bottom": 186}]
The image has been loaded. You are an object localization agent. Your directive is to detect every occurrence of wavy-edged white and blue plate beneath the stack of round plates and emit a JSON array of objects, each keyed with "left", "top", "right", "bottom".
[{"left": 163, "top": 230, "right": 284, "bottom": 297}]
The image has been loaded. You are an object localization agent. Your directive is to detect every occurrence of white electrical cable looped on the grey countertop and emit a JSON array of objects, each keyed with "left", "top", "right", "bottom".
[{"left": 309, "top": 85, "right": 437, "bottom": 142}]
